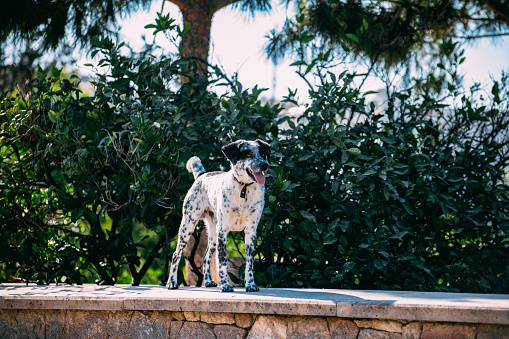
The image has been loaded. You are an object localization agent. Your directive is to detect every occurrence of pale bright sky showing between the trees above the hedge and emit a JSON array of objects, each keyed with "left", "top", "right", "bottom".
[{"left": 111, "top": 0, "right": 509, "bottom": 100}]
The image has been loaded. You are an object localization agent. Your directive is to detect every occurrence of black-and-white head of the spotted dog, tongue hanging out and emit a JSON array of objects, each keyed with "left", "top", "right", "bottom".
[{"left": 221, "top": 139, "right": 270, "bottom": 185}]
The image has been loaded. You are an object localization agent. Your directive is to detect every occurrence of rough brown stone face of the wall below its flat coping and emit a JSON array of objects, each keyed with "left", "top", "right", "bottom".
[{"left": 0, "top": 310, "right": 509, "bottom": 339}]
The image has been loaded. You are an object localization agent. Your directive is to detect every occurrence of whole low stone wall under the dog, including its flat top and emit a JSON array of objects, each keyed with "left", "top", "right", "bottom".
[{"left": 0, "top": 285, "right": 509, "bottom": 339}]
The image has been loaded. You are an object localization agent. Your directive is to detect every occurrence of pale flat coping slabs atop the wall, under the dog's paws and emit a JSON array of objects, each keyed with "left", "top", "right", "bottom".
[{"left": 0, "top": 284, "right": 509, "bottom": 325}]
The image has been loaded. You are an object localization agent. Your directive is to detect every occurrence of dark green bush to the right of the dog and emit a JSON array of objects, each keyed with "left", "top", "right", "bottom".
[{"left": 258, "top": 70, "right": 509, "bottom": 293}]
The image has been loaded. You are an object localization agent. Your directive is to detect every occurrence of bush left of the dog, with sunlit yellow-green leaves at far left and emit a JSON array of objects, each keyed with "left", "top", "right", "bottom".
[{"left": 0, "top": 31, "right": 277, "bottom": 285}]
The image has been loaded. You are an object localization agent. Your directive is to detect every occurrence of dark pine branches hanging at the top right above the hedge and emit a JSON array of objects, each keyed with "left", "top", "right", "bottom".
[{"left": 266, "top": 0, "right": 509, "bottom": 81}]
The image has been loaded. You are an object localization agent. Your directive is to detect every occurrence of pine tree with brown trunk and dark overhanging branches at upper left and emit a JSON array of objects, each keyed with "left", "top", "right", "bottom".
[{"left": 0, "top": 0, "right": 271, "bottom": 92}]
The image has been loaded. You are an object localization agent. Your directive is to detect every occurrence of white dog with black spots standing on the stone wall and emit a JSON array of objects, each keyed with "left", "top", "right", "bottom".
[{"left": 166, "top": 139, "right": 270, "bottom": 292}]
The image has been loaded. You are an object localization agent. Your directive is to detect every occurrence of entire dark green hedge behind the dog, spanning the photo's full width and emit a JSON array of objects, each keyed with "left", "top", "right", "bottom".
[{"left": 0, "top": 24, "right": 509, "bottom": 293}]
